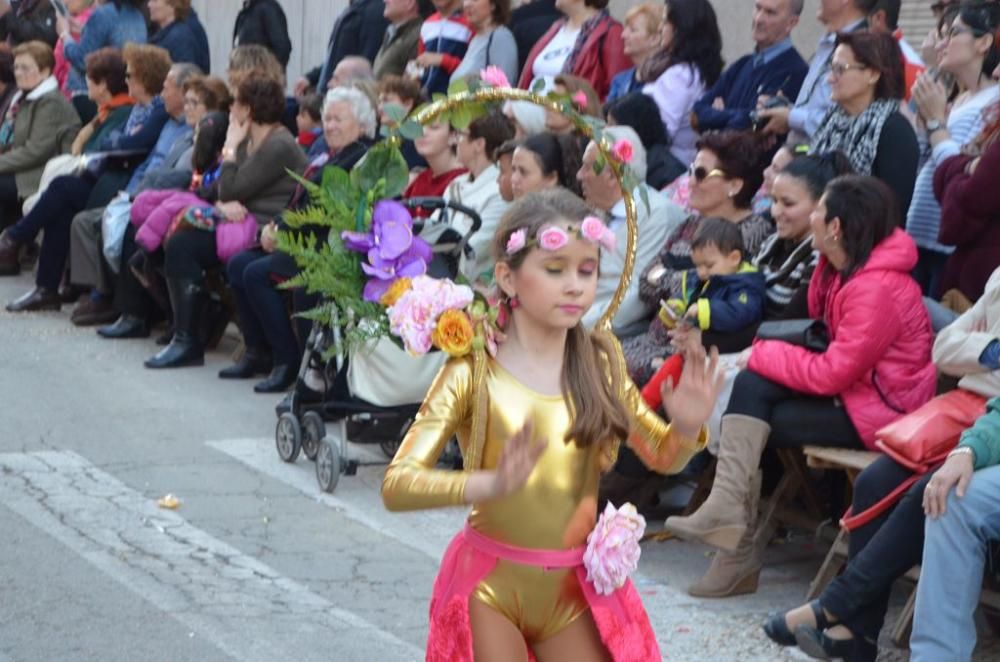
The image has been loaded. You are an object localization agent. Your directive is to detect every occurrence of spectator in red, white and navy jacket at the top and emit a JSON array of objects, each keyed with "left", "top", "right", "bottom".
[{"left": 414, "top": 0, "right": 473, "bottom": 96}]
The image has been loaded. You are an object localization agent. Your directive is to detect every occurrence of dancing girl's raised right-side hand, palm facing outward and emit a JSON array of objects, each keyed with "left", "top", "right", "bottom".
[{"left": 660, "top": 345, "right": 725, "bottom": 439}]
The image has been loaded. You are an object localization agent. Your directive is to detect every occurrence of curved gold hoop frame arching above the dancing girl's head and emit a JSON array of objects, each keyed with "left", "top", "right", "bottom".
[{"left": 411, "top": 87, "right": 639, "bottom": 329}]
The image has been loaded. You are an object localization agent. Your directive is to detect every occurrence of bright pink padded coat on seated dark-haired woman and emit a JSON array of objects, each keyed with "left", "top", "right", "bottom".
[{"left": 749, "top": 229, "right": 937, "bottom": 450}]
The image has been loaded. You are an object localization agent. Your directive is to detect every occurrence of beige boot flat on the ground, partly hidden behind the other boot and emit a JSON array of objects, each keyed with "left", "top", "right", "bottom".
[{"left": 688, "top": 471, "right": 762, "bottom": 598}]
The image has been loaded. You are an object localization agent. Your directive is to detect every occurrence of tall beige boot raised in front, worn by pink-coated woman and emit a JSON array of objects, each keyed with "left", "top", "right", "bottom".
[{"left": 665, "top": 414, "right": 771, "bottom": 552}]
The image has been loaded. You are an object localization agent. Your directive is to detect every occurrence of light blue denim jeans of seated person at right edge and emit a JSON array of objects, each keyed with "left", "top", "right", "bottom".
[{"left": 910, "top": 466, "right": 1000, "bottom": 662}]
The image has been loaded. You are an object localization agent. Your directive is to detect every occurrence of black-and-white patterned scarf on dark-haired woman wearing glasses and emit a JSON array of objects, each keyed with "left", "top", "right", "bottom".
[{"left": 810, "top": 99, "right": 899, "bottom": 175}]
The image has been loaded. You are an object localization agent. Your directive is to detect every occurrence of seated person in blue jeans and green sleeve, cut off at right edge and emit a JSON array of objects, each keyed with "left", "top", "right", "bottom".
[{"left": 910, "top": 398, "right": 1000, "bottom": 662}]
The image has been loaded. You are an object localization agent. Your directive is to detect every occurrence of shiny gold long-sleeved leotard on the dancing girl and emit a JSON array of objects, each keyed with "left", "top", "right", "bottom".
[{"left": 382, "top": 338, "right": 707, "bottom": 644}]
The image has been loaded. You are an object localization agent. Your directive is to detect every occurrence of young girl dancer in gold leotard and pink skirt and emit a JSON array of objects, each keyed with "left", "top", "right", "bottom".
[{"left": 382, "top": 189, "right": 721, "bottom": 662}]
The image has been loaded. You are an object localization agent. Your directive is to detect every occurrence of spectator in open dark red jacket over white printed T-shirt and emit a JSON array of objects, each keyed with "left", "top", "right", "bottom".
[{"left": 518, "top": 0, "right": 628, "bottom": 99}]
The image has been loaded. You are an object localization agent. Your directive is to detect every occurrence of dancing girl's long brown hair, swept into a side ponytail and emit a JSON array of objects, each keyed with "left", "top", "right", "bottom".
[{"left": 493, "top": 188, "right": 630, "bottom": 446}]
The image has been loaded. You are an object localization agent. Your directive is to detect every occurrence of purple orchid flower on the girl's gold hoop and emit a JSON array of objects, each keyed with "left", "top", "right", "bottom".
[{"left": 340, "top": 200, "right": 433, "bottom": 301}]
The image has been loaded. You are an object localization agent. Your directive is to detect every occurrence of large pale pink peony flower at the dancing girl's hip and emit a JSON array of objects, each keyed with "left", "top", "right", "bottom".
[{"left": 583, "top": 502, "right": 646, "bottom": 595}]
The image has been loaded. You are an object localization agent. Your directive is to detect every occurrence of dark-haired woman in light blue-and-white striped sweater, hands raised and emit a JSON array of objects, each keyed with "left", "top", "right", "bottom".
[{"left": 906, "top": 4, "right": 1000, "bottom": 297}]
